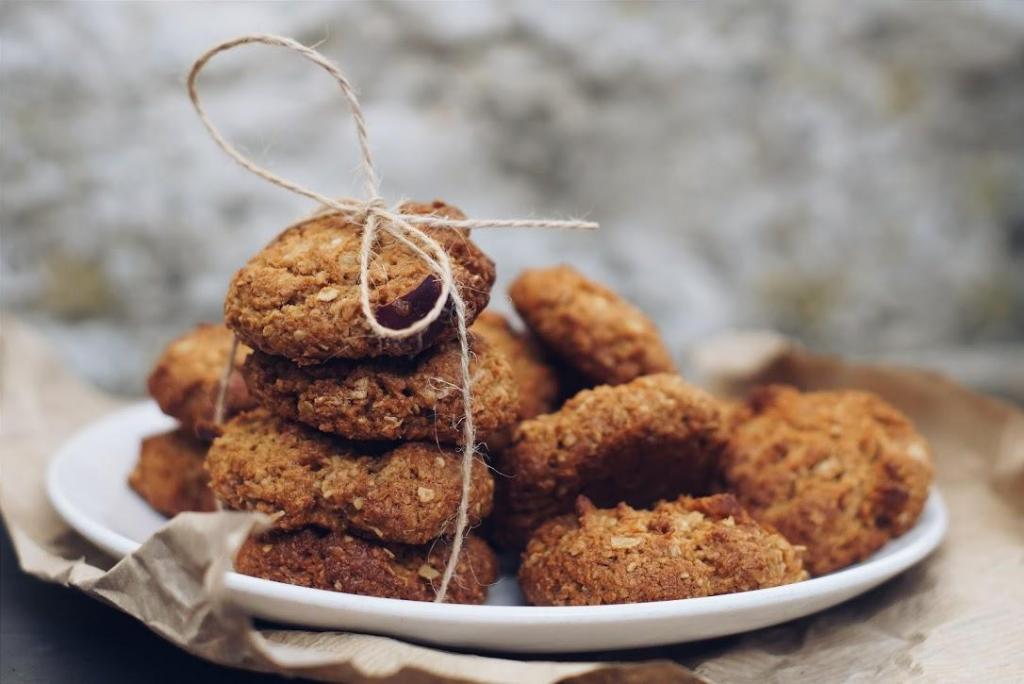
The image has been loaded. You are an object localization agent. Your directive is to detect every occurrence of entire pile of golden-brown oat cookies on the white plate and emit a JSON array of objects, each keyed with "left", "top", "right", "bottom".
[{"left": 131, "top": 237, "right": 932, "bottom": 605}]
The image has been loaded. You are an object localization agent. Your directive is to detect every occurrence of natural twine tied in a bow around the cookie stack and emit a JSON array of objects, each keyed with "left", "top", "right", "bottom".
[{"left": 187, "top": 34, "right": 597, "bottom": 603}]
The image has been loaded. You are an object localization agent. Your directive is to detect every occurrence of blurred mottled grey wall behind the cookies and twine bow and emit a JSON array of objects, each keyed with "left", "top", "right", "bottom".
[{"left": 0, "top": 0, "right": 1024, "bottom": 399}]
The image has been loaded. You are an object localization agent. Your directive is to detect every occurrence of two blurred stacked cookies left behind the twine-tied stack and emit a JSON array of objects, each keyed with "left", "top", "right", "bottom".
[{"left": 128, "top": 324, "right": 256, "bottom": 516}]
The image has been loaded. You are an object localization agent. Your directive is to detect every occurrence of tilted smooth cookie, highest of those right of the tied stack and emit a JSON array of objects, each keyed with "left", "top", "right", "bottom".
[{"left": 509, "top": 266, "right": 675, "bottom": 385}]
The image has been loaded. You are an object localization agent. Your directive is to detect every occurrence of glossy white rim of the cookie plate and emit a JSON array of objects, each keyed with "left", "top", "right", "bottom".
[{"left": 45, "top": 400, "right": 949, "bottom": 626}]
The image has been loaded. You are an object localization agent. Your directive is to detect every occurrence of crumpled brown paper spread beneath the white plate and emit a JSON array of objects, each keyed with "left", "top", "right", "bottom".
[{"left": 0, "top": 318, "right": 1024, "bottom": 682}]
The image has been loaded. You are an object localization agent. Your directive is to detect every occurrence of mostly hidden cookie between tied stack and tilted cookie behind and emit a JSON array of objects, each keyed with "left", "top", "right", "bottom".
[{"left": 473, "top": 310, "right": 559, "bottom": 420}]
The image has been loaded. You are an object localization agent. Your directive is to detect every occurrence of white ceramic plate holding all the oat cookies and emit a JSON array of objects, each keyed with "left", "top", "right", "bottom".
[{"left": 47, "top": 402, "right": 947, "bottom": 652}]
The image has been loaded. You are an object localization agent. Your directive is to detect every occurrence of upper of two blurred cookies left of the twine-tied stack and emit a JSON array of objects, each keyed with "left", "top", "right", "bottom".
[{"left": 146, "top": 324, "right": 256, "bottom": 439}]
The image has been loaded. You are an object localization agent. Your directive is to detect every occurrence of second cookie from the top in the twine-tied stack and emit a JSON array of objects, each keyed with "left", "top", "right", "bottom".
[{"left": 242, "top": 331, "right": 518, "bottom": 444}]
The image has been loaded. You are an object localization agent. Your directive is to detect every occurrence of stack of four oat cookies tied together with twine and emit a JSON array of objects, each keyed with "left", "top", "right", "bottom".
[{"left": 207, "top": 202, "right": 519, "bottom": 603}]
